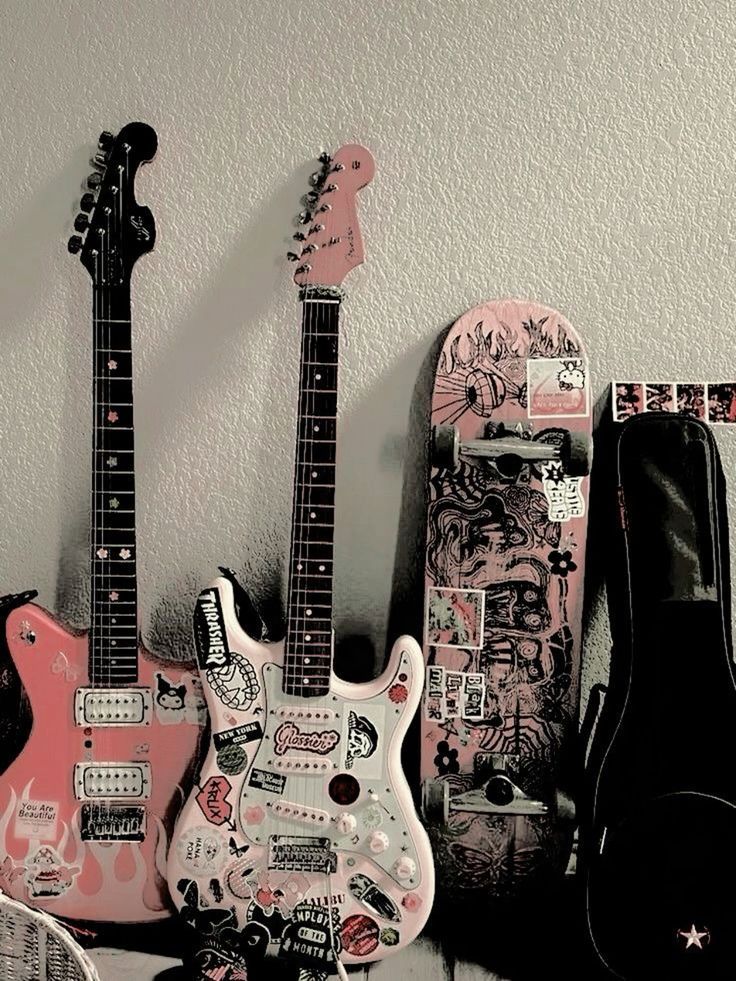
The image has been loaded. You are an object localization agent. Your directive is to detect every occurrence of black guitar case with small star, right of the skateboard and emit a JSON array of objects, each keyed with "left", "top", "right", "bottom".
[{"left": 582, "top": 413, "right": 736, "bottom": 981}]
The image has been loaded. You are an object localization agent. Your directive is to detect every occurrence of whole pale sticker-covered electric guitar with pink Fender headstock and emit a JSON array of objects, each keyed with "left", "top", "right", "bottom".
[{"left": 169, "top": 146, "right": 434, "bottom": 976}]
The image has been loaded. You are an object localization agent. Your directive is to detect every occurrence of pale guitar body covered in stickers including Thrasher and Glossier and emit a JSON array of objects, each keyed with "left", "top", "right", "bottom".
[{"left": 169, "top": 579, "right": 433, "bottom": 965}]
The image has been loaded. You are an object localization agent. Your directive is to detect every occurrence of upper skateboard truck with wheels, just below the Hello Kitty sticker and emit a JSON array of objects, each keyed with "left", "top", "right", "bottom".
[{"left": 432, "top": 426, "right": 592, "bottom": 477}]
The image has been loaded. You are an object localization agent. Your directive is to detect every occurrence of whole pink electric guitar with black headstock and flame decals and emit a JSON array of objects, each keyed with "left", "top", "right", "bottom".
[{"left": 0, "top": 123, "right": 206, "bottom": 922}]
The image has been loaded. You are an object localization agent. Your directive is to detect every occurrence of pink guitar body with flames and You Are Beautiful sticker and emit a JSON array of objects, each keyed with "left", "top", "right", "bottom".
[{"left": 0, "top": 604, "right": 206, "bottom": 923}]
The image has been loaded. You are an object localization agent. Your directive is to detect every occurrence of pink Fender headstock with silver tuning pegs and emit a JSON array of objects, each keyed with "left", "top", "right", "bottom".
[{"left": 288, "top": 143, "right": 376, "bottom": 286}]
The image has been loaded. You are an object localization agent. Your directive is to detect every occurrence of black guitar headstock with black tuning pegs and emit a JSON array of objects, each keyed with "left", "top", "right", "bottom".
[{"left": 69, "top": 123, "right": 158, "bottom": 287}]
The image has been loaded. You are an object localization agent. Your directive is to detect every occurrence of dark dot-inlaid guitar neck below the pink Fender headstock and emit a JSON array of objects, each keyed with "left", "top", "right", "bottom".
[{"left": 283, "top": 287, "right": 342, "bottom": 698}]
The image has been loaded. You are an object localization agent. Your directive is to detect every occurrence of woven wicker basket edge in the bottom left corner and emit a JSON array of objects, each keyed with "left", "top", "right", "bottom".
[{"left": 0, "top": 892, "right": 100, "bottom": 981}]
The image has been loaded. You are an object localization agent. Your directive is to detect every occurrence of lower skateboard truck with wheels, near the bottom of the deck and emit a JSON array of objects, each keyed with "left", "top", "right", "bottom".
[{"left": 422, "top": 753, "right": 575, "bottom": 824}]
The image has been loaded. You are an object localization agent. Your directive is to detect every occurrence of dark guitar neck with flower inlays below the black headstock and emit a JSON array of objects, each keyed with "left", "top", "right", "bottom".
[{"left": 89, "top": 282, "right": 138, "bottom": 687}]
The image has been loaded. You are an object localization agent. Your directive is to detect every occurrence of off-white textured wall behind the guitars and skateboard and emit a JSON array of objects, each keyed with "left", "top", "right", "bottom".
[{"left": 0, "top": 0, "right": 736, "bottom": 977}]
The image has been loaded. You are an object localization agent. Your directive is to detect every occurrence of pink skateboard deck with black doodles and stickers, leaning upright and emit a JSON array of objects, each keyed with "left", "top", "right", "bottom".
[{"left": 421, "top": 300, "right": 592, "bottom": 897}]
